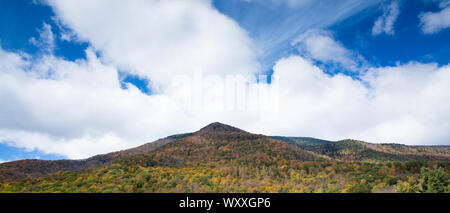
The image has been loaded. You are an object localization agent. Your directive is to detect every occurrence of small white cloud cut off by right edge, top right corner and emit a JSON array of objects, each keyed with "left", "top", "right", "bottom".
[{"left": 419, "top": 3, "right": 450, "bottom": 34}]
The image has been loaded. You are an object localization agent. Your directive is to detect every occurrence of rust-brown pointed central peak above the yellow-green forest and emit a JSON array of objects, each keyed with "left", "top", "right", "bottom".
[{"left": 121, "top": 123, "right": 322, "bottom": 169}]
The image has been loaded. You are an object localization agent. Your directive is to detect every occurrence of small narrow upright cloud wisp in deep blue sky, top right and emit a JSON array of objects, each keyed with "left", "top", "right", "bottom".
[{"left": 372, "top": 1, "right": 400, "bottom": 35}]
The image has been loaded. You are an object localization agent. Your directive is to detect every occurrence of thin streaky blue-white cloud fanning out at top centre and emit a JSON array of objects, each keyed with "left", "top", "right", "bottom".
[{"left": 223, "top": 0, "right": 384, "bottom": 71}]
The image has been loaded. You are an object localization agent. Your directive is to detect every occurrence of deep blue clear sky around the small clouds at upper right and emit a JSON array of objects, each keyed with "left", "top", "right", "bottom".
[{"left": 330, "top": 1, "right": 450, "bottom": 66}]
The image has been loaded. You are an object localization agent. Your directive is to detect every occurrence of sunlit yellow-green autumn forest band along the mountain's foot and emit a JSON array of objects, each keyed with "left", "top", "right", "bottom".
[{"left": 0, "top": 160, "right": 448, "bottom": 193}]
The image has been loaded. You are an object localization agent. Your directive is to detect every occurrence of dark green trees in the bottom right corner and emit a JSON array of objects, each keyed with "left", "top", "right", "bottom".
[{"left": 420, "top": 167, "right": 449, "bottom": 193}]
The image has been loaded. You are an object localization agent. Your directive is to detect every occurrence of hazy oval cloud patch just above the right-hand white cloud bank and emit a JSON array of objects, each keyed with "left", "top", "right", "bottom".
[{"left": 292, "top": 29, "right": 365, "bottom": 71}]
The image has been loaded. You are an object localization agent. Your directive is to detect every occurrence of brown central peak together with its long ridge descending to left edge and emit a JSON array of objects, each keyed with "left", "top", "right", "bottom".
[{"left": 0, "top": 122, "right": 320, "bottom": 182}]
